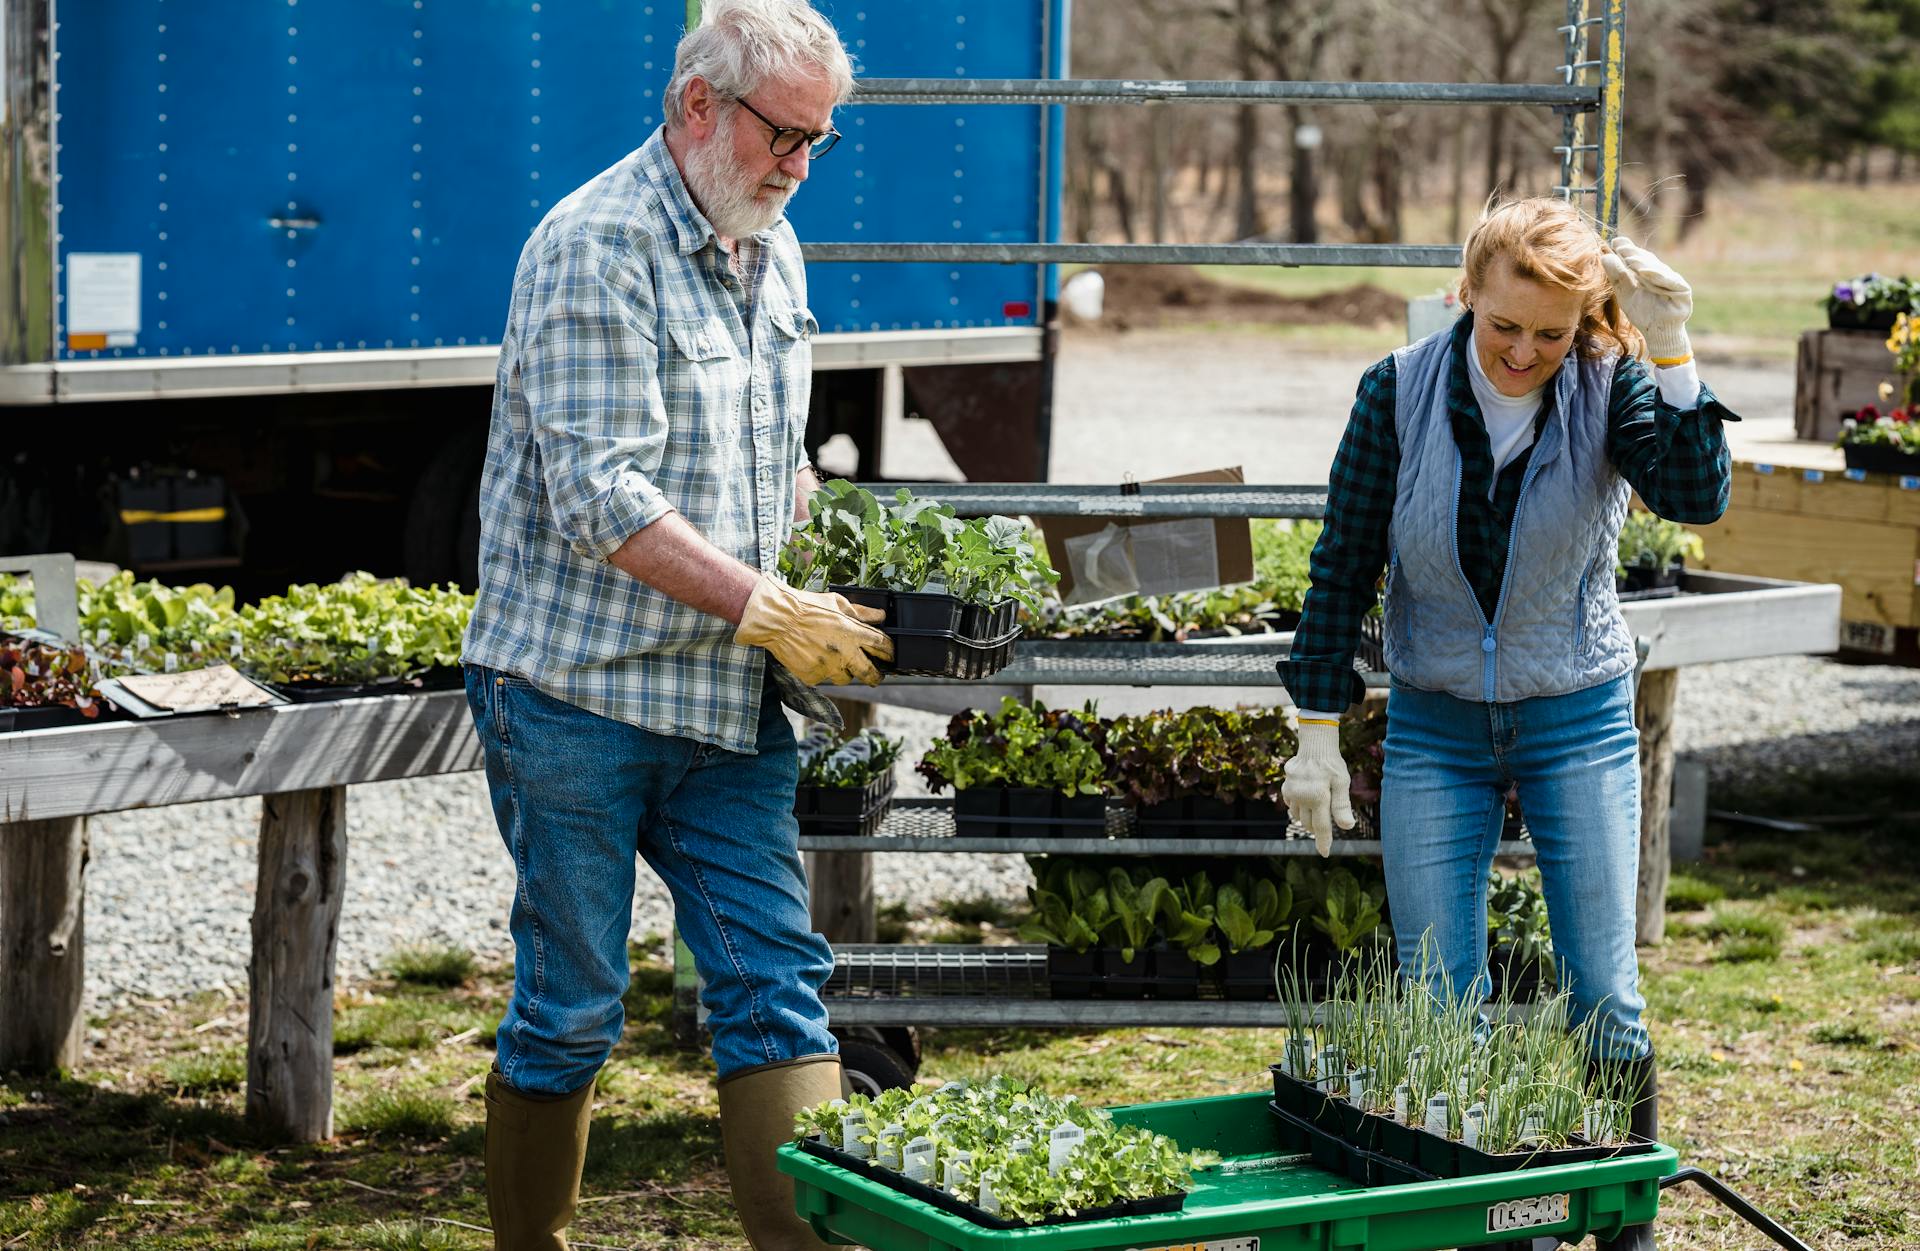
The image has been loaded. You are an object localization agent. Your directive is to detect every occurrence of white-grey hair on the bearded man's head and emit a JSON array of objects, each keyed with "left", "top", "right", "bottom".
[{"left": 660, "top": 0, "right": 852, "bottom": 130}]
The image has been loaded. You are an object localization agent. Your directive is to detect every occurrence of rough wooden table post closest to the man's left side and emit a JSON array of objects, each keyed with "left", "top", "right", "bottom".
[{"left": 246, "top": 787, "right": 348, "bottom": 1142}]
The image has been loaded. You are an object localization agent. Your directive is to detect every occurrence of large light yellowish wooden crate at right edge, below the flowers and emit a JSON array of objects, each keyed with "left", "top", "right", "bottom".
[{"left": 1695, "top": 458, "right": 1920, "bottom": 627}]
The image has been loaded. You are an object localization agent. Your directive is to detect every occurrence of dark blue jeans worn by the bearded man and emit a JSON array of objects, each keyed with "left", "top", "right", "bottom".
[{"left": 467, "top": 664, "right": 839, "bottom": 1094}]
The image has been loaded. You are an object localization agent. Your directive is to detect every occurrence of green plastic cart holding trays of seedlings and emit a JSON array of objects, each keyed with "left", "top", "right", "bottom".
[{"left": 780, "top": 1092, "right": 1678, "bottom": 1251}]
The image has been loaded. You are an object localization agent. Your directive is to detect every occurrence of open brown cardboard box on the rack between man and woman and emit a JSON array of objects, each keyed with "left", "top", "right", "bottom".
[{"left": 1033, "top": 466, "right": 1254, "bottom": 604}]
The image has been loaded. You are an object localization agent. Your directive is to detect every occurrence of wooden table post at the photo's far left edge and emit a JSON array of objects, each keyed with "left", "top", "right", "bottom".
[{"left": 0, "top": 817, "right": 86, "bottom": 1073}]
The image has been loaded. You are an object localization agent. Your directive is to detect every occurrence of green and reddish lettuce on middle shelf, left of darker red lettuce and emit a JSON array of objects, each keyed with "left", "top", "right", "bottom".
[{"left": 916, "top": 695, "right": 1110, "bottom": 794}]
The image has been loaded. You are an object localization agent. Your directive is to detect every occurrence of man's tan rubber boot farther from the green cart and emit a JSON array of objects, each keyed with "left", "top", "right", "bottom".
[{"left": 486, "top": 1069, "right": 593, "bottom": 1251}]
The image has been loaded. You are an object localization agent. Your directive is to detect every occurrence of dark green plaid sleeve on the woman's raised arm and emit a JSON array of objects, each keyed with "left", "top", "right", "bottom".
[{"left": 1607, "top": 357, "right": 1740, "bottom": 526}]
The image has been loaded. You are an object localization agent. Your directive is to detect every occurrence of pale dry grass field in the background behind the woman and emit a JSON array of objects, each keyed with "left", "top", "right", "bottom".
[{"left": 1202, "top": 180, "right": 1920, "bottom": 357}]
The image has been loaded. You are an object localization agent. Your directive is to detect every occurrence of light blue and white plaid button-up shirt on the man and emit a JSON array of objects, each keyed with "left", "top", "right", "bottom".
[{"left": 463, "top": 130, "right": 816, "bottom": 752}]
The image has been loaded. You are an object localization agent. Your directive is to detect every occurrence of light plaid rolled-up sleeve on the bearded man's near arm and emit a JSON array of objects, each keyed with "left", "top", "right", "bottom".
[{"left": 518, "top": 236, "right": 672, "bottom": 560}]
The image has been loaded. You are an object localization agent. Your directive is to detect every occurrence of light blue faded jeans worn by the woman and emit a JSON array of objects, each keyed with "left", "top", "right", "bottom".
[{"left": 1380, "top": 677, "right": 1647, "bottom": 1059}]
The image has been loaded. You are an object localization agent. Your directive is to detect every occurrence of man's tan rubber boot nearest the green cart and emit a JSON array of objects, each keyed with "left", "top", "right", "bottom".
[{"left": 720, "top": 1055, "right": 841, "bottom": 1251}]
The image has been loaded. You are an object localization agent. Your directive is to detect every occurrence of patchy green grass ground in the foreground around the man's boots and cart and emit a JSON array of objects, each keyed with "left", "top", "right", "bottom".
[{"left": 0, "top": 771, "right": 1920, "bottom": 1251}]
